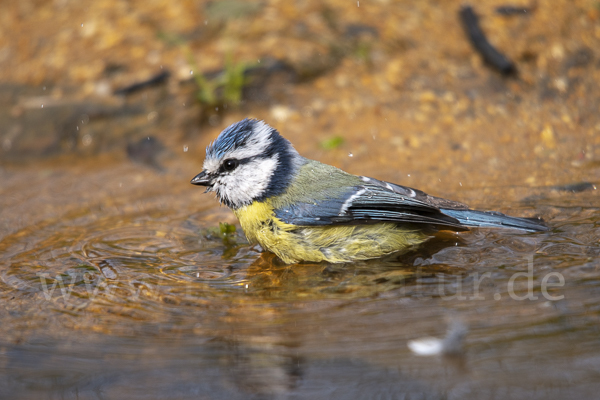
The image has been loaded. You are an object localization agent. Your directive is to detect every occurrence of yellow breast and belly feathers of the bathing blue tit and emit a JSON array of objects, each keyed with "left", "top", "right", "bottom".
[{"left": 234, "top": 200, "right": 428, "bottom": 264}]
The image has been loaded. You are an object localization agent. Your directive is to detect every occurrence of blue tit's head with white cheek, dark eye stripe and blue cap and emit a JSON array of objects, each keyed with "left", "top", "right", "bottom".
[{"left": 191, "top": 119, "right": 304, "bottom": 209}]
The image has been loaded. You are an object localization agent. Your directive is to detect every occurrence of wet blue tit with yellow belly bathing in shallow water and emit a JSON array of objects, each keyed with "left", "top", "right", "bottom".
[{"left": 191, "top": 119, "right": 547, "bottom": 264}]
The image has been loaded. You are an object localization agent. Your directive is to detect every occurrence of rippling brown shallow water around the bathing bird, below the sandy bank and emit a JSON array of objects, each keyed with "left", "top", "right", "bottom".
[{"left": 0, "top": 155, "right": 600, "bottom": 399}]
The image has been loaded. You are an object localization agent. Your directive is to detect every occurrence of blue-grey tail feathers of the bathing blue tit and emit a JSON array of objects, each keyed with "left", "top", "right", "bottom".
[{"left": 441, "top": 209, "right": 548, "bottom": 232}]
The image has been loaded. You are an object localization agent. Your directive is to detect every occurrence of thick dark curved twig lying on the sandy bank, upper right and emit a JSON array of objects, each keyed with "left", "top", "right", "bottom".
[{"left": 459, "top": 6, "right": 516, "bottom": 75}]
